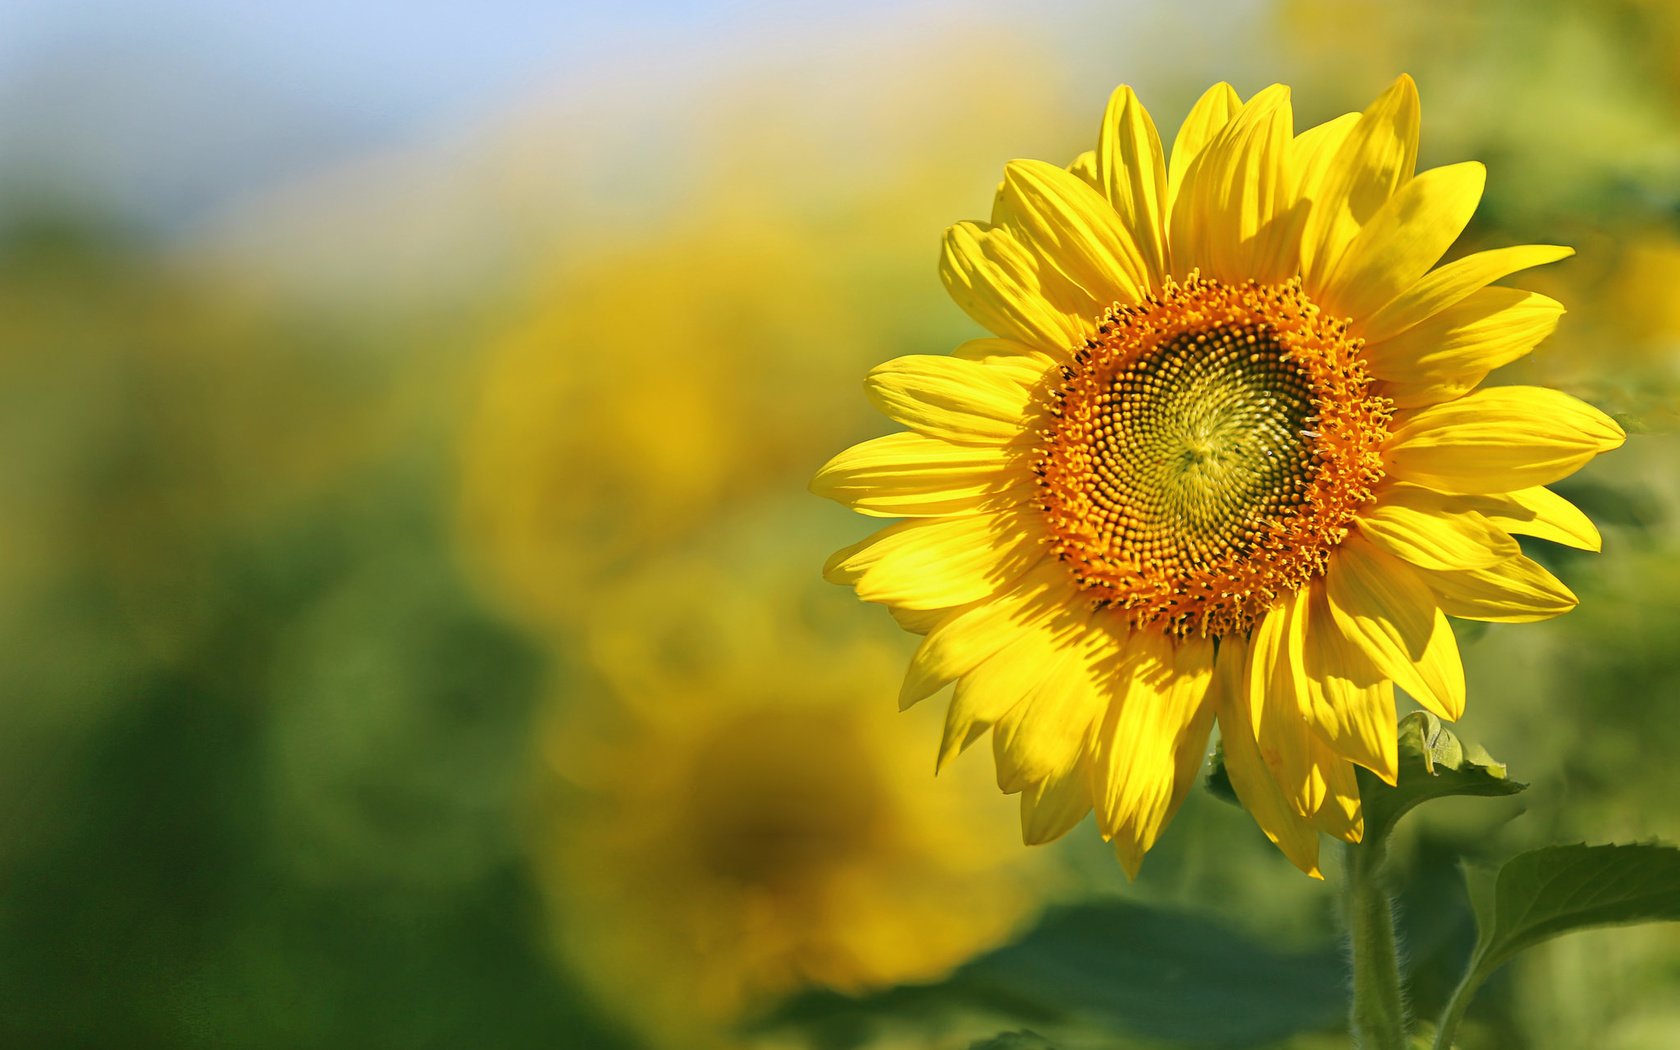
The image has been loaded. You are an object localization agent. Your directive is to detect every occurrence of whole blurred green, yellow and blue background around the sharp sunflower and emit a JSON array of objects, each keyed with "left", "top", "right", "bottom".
[{"left": 0, "top": 0, "right": 1680, "bottom": 1050}]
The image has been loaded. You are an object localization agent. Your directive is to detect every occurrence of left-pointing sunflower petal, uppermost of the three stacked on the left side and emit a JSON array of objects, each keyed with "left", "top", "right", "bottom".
[{"left": 864, "top": 354, "right": 1032, "bottom": 445}]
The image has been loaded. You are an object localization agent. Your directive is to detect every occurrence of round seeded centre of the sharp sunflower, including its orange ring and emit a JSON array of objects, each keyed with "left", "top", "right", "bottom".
[{"left": 1033, "top": 274, "right": 1393, "bottom": 637}]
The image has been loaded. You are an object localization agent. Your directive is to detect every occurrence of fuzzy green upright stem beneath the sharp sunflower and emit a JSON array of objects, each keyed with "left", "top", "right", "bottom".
[{"left": 1347, "top": 842, "right": 1406, "bottom": 1050}]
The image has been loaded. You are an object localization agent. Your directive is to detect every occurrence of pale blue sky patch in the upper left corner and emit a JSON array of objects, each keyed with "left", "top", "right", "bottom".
[{"left": 0, "top": 0, "right": 906, "bottom": 228}]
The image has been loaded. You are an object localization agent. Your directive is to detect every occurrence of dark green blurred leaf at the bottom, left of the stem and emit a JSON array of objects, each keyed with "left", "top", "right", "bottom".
[{"left": 754, "top": 899, "right": 1347, "bottom": 1048}]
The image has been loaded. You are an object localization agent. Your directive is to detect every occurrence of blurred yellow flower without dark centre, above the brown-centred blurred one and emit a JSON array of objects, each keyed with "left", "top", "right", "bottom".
[{"left": 460, "top": 223, "right": 852, "bottom": 633}]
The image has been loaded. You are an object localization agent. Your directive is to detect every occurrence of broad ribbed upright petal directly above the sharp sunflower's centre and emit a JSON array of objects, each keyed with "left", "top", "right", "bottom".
[{"left": 1171, "top": 84, "right": 1305, "bottom": 281}]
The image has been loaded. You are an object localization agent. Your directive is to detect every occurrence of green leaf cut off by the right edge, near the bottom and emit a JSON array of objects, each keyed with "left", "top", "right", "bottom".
[{"left": 1470, "top": 845, "right": 1680, "bottom": 978}]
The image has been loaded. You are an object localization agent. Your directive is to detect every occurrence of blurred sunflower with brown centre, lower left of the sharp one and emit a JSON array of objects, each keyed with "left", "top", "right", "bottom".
[{"left": 538, "top": 559, "right": 1045, "bottom": 1050}]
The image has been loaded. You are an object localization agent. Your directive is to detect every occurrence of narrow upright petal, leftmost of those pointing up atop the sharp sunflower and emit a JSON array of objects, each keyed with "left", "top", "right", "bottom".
[{"left": 1094, "top": 84, "right": 1168, "bottom": 287}]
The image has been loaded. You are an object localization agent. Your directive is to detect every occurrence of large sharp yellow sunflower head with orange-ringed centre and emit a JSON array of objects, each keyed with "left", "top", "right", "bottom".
[{"left": 813, "top": 76, "right": 1625, "bottom": 875}]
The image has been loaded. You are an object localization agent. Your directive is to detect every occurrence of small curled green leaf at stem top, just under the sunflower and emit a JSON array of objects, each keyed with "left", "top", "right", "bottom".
[{"left": 1357, "top": 711, "right": 1527, "bottom": 843}]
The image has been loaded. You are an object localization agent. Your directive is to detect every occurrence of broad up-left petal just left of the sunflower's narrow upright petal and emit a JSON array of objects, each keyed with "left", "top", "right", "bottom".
[{"left": 993, "top": 160, "right": 1149, "bottom": 309}]
